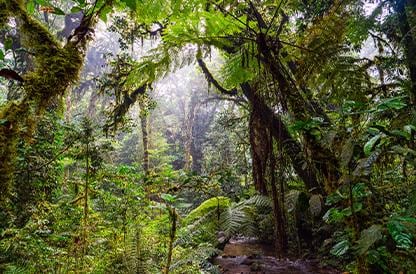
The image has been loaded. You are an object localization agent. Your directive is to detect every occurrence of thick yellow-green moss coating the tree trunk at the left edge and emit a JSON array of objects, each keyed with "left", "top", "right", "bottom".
[{"left": 0, "top": 0, "right": 90, "bottom": 207}]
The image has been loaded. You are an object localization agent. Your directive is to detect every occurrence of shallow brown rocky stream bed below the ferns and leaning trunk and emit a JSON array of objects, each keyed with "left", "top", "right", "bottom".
[{"left": 214, "top": 238, "right": 341, "bottom": 274}]
